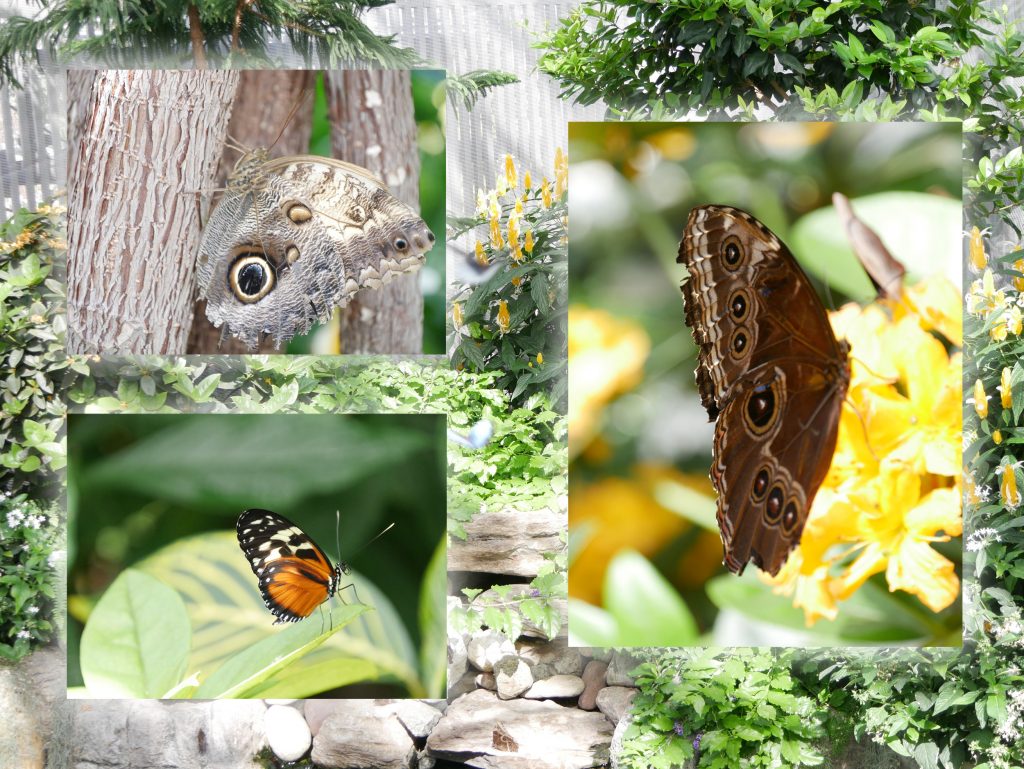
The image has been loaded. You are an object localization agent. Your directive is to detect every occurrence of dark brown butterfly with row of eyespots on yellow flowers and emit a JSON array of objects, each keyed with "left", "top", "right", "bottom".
[{"left": 678, "top": 206, "right": 850, "bottom": 575}]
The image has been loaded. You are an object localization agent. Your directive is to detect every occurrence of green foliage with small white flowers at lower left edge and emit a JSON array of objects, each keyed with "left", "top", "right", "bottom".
[{"left": 0, "top": 495, "right": 60, "bottom": 660}]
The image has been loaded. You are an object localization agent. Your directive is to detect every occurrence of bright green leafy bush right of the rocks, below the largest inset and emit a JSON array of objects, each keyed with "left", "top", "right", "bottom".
[{"left": 620, "top": 649, "right": 825, "bottom": 769}]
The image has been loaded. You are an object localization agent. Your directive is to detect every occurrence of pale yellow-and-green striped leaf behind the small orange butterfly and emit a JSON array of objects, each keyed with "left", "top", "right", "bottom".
[{"left": 139, "top": 531, "right": 425, "bottom": 698}]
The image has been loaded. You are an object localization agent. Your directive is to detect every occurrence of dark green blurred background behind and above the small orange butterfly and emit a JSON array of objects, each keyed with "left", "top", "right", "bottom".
[{"left": 68, "top": 414, "right": 446, "bottom": 686}]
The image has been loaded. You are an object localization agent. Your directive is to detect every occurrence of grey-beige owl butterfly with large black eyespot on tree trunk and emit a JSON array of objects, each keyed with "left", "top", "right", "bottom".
[{"left": 197, "top": 149, "right": 434, "bottom": 347}]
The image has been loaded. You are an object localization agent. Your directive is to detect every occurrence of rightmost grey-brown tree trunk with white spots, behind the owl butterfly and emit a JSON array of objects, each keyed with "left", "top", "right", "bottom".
[{"left": 327, "top": 71, "right": 423, "bottom": 353}]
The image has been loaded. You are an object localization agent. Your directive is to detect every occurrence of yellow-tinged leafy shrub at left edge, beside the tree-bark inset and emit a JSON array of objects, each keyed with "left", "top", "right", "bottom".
[{"left": 0, "top": 206, "right": 69, "bottom": 496}]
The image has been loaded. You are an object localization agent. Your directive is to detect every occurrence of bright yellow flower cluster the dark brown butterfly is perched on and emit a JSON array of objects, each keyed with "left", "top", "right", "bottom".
[{"left": 763, "top": 277, "right": 963, "bottom": 626}]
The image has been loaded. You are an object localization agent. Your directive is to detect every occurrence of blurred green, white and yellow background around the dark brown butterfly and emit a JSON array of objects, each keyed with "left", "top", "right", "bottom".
[{"left": 569, "top": 123, "right": 963, "bottom": 645}]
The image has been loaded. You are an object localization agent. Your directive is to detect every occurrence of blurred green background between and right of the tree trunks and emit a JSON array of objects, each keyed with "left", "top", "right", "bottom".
[{"left": 288, "top": 70, "right": 446, "bottom": 355}]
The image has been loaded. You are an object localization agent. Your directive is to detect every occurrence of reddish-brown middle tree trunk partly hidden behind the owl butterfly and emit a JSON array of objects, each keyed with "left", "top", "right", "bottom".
[{"left": 188, "top": 70, "right": 315, "bottom": 354}]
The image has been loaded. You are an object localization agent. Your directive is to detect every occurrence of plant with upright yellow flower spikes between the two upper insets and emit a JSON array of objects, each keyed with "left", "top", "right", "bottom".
[{"left": 449, "top": 153, "right": 568, "bottom": 411}]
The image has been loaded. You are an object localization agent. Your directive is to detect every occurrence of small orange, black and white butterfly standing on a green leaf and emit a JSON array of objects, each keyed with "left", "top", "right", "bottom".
[{"left": 234, "top": 508, "right": 351, "bottom": 625}]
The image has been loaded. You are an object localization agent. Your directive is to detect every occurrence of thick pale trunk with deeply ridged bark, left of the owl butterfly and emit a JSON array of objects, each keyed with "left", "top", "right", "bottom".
[{"left": 68, "top": 71, "right": 239, "bottom": 354}]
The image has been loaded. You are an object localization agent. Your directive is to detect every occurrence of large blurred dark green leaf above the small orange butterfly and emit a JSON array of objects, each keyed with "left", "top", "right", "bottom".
[{"left": 80, "top": 415, "right": 428, "bottom": 510}]
